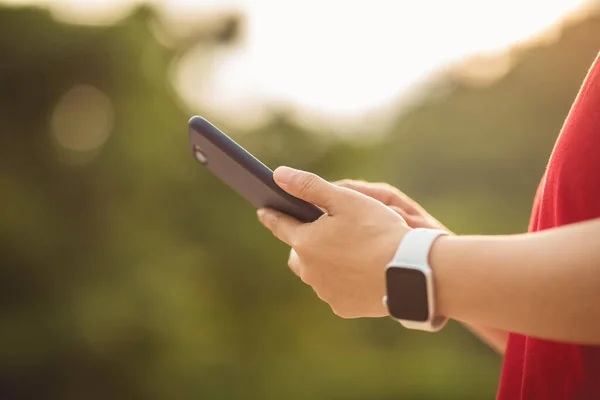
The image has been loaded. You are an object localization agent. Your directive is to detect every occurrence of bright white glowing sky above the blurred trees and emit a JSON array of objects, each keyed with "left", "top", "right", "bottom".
[{"left": 4, "top": 0, "right": 583, "bottom": 130}]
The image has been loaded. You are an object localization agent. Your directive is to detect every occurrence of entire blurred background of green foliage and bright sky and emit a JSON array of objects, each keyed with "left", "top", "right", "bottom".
[{"left": 0, "top": 0, "right": 600, "bottom": 400}]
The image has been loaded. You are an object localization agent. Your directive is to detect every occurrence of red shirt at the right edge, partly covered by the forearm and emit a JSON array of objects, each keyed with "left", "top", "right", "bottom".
[{"left": 498, "top": 51, "right": 600, "bottom": 400}]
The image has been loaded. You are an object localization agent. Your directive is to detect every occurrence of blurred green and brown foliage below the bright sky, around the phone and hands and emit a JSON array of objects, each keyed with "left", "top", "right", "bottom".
[{"left": 0, "top": 3, "right": 600, "bottom": 400}]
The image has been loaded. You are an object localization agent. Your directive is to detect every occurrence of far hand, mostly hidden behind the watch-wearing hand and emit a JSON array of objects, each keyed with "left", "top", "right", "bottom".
[{"left": 334, "top": 179, "right": 448, "bottom": 231}]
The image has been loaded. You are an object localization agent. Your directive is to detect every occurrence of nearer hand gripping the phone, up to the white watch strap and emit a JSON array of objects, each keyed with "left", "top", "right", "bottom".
[{"left": 258, "top": 167, "right": 410, "bottom": 318}]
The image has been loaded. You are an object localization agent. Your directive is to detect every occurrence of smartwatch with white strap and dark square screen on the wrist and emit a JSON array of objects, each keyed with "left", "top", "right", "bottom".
[{"left": 383, "top": 228, "right": 448, "bottom": 332}]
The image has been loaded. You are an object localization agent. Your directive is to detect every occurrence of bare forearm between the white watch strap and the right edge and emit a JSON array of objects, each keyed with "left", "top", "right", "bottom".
[{"left": 430, "top": 220, "right": 600, "bottom": 344}]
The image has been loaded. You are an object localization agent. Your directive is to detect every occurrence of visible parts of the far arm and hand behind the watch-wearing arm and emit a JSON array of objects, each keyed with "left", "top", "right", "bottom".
[{"left": 336, "top": 180, "right": 508, "bottom": 354}]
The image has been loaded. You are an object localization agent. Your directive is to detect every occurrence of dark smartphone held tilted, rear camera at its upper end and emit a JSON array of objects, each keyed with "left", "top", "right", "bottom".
[{"left": 189, "top": 116, "right": 323, "bottom": 222}]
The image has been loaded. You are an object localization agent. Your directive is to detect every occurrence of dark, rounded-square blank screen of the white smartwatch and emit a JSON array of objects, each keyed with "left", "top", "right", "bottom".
[{"left": 386, "top": 267, "right": 429, "bottom": 322}]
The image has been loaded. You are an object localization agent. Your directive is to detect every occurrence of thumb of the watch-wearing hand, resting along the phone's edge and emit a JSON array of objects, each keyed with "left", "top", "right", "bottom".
[{"left": 273, "top": 167, "right": 344, "bottom": 215}]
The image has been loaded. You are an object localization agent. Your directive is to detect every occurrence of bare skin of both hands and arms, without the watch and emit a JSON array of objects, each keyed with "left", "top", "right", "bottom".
[{"left": 258, "top": 167, "right": 600, "bottom": 351}]
